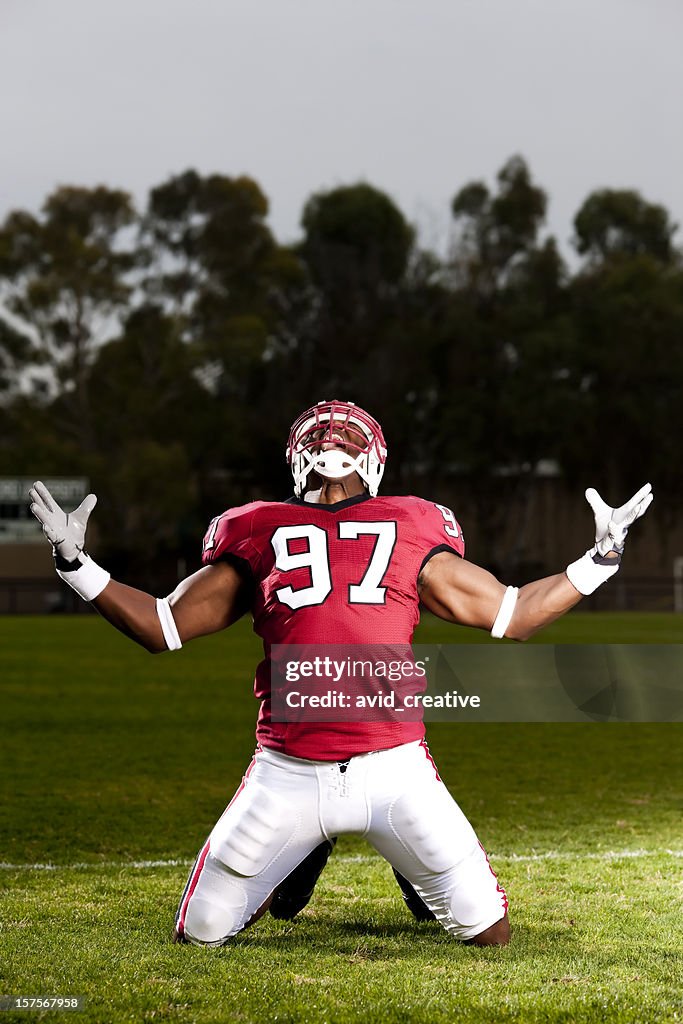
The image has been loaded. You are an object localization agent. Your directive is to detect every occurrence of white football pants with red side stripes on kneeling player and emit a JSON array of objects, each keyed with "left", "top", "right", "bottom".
[{"left": 176, "top": 739, "right": 508, "bottom": 945}]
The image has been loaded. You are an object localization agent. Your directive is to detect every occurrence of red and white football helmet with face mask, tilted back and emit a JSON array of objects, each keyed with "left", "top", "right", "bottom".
[{"left": 286, "top": 401, "right": 387, "bottom": 498}]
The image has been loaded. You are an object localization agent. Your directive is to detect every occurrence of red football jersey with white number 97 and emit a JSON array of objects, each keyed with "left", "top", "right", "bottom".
[{"left": 202, "top": 494, "right": 465, "bottom": 761}]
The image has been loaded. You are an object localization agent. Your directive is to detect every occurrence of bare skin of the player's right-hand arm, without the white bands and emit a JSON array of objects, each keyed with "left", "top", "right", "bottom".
[{"left": 418, "top": 551, "right": 582, "bottom": 640}]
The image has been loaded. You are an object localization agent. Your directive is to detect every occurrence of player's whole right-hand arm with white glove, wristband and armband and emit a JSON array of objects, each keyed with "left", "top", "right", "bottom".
[{"left": 418, "top": 483, "right": 653, "bottom": 640}]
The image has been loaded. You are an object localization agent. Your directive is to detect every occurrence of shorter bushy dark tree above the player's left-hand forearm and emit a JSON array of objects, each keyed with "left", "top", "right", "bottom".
[{"left": 82, "top": 305, "right": 211, "bottom": 574}]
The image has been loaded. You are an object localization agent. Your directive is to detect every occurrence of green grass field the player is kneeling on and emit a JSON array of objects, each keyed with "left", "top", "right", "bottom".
[{"left": 0, "top": 613, "right": 683, "bottom": 1024}]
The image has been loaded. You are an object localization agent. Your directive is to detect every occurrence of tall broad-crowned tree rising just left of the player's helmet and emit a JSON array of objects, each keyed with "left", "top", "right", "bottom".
[{"left": 143, "top": 170, "right": 303, "bottom": 498}]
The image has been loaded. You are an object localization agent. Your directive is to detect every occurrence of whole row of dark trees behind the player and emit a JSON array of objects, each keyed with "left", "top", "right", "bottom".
[{"left": 0, "top": 157, "right": 683, "bottom": 571}]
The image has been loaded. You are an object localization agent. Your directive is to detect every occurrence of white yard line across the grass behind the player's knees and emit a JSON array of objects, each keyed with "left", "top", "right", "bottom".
[{"left": 0, "top": 850, "right": 683, "bottom": 871}]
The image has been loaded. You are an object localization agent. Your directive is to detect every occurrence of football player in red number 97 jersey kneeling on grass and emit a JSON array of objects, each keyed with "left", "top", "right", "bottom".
[{"left": 31, "top": 401, "right": 652, "bottom": 945}]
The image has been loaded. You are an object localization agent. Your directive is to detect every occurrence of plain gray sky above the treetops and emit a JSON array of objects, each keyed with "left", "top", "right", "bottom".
[{"left": 0, "top": 0, "right": 683, "bottom": 260}]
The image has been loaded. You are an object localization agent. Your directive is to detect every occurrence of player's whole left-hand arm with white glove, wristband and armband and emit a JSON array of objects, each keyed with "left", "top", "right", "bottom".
[{"left": 30, "top": 481, "right": 248, "bottom": 653}]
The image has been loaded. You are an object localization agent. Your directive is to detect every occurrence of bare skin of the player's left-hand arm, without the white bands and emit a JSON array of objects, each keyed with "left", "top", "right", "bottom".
[{"left": 92, "top": 562, "right": 248, "bottom": 654}]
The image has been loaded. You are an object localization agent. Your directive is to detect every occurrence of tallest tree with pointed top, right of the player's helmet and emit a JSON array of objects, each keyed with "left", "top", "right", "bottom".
[{"left": 431, "top": 157, "right": 574, "bottom": 575}]
